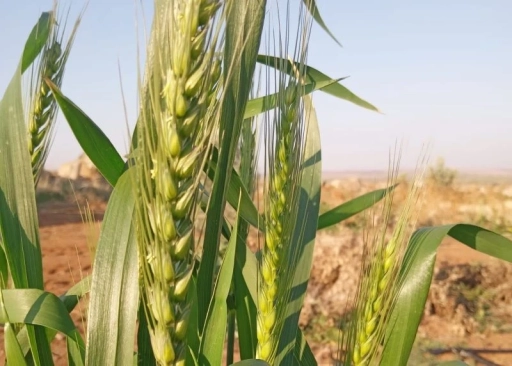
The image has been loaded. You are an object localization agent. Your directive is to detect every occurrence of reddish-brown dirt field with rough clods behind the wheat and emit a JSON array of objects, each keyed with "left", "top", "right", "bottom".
[{"left": 0, "top": 174, "right": 512, "bottom": 365}]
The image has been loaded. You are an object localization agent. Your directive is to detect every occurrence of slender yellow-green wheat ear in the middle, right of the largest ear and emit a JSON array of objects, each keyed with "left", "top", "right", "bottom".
[{"left": 256, "top": 8, "right": 309, "bottom": 364}]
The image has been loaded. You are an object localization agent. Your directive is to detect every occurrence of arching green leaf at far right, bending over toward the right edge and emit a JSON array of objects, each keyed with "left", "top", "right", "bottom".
[{"left": 381, "top": 224, "right": 512, "bottom": 366}]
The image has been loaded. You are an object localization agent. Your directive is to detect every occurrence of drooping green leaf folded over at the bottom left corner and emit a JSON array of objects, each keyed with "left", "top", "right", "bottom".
[{"left": 0, "top": 289, "right": 85, "bottom": 350}]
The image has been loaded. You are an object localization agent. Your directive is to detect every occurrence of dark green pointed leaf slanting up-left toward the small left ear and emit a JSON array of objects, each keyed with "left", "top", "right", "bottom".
[{"left": 46, "top": 79, "right": 125, "bottom": 186}]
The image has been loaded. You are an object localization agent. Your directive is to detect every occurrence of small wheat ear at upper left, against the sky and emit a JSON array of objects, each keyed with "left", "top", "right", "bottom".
[{"left": 28, "top": 6, "right": 82, "bottom": 184}]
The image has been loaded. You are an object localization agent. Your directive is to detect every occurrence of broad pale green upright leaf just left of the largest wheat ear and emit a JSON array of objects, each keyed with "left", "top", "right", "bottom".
[{"left": 86, "top": 170, "right": 139, "bottom": 365}]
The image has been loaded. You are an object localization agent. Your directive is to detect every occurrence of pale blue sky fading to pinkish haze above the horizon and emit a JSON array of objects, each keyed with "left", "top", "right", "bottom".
[{"left": 0, "top": 0, "right": 512, "bottom": 171}]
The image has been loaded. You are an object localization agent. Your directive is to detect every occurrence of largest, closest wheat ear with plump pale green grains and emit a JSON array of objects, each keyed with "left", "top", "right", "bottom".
[{"left": 136, "top": 0, "right": 221, "bottom": 365}]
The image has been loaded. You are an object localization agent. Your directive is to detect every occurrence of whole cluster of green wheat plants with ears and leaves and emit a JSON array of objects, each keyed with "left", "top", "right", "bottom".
[{"left": 0, "top": 0, "right": 512, "bottom": 366}]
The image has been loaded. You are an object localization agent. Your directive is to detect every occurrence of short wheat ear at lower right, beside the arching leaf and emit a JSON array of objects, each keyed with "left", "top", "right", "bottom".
[{"left": 347, "top": 149, "right": 424, "bottom": 366}]
